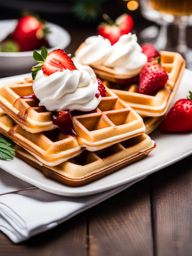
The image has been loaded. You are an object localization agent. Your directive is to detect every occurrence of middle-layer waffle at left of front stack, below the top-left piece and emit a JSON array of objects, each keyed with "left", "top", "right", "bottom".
[{"left": 0, "top": 110, "right": 81, "bottom": 166}]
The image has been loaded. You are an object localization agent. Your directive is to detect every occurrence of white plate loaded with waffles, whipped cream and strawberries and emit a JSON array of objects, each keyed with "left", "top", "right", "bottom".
[{"left": 0, "top": 34, "right": 191, "bottom": 196}]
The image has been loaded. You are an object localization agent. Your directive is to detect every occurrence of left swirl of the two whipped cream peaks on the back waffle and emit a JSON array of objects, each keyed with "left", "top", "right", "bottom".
[{"left": 76, "top": 36, "right": 111, "bottom": 65}]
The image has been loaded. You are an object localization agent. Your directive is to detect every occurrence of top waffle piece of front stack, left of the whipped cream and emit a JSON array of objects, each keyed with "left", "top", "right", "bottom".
[{"left": 0, "top": 77, "right": 55, "bottom": 133}]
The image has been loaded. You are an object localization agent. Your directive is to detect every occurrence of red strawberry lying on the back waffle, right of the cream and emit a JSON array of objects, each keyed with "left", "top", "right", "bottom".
[{"left": 139, "top": 62, "right": 168, "bottom": 95}]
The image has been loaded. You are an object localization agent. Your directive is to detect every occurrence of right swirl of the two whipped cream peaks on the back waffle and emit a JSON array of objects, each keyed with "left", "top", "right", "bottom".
[{"left": 103, "top": 33, "right": 147, "bottom": 77}]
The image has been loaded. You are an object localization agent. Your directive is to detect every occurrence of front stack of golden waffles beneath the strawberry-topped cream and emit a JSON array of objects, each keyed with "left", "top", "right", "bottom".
[{"left": 0, "top": 77, "right": 154, "bottom": 186}]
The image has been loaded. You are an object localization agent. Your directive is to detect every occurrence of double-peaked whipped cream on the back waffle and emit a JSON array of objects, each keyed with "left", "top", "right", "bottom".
[{"left": 76, "top": 33, "right": 147, "bottom": 77}]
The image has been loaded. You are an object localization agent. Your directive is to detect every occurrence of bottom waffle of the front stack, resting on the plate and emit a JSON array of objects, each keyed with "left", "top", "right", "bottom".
[{"left": 16, "top": 134, "right": 155, "bottom": 186}]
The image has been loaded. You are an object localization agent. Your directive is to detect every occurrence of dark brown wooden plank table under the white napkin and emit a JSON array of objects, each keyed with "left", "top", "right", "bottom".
[{"left": 0, "top": 23, "right": 192, "bottom": 256}]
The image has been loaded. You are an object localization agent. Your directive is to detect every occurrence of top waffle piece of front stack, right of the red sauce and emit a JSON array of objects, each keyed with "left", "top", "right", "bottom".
[{"left": 73, "top": 90, "right": 145, "bottom": 151}]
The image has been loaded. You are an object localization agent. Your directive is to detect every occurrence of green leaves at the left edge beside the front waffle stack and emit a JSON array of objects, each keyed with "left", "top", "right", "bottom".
[{"left": 0, "top": 135, "right": 15, "bottom": 160}]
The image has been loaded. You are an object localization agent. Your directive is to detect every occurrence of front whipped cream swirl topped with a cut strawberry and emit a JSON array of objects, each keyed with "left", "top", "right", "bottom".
[{"left": 33, "top": 63, "right": 101, "bottom": 111}]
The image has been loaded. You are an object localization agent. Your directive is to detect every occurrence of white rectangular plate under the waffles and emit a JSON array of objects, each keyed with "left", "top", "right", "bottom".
[{"left": 0, "top": 70, "right": 192, "bottom": 197}]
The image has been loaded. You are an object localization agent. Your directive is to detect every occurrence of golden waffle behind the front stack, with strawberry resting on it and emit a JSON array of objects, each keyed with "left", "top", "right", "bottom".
[{"left": 105, "top": 51, "right": 185, "bottom": 117}]
